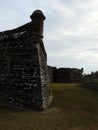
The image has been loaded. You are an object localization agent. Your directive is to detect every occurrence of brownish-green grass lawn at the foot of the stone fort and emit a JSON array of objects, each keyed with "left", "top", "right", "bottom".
[{"left": 0, "top": 83, "right": 98, "bottom": 130}]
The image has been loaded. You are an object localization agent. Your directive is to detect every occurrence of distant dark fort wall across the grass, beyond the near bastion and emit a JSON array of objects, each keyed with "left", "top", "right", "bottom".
[{"left": 48, "top": 66, "right": 83, "bottom": 83}]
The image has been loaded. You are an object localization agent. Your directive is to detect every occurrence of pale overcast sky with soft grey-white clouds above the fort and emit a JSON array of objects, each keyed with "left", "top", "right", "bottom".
[{"left": 0, "top": 0, "right": 98, "bottom": 73}]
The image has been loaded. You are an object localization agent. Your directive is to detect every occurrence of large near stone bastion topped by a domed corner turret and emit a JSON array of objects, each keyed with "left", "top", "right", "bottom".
[{"left": 0, "top": 10, "right": 52, "bottom": 110}]
